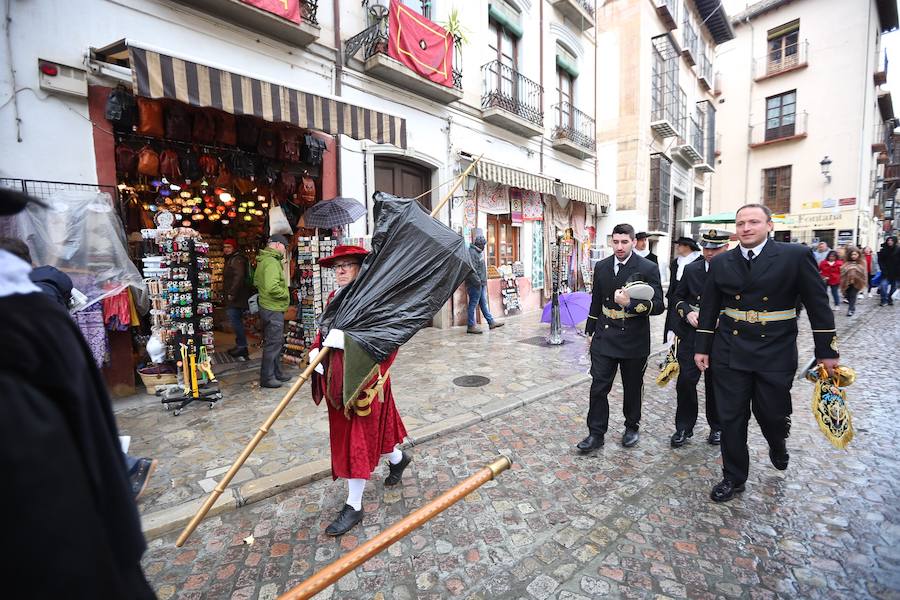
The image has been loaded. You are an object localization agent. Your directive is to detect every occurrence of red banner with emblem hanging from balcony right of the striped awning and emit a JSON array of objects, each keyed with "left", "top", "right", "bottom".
[{"left": 388, "top": 0, "right": 453, "bottom": 87}]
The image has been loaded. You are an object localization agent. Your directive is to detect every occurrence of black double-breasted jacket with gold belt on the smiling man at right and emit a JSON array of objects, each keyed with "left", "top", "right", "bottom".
[{"left": 694, "top": 240, "right": 838, "bottom": 371}]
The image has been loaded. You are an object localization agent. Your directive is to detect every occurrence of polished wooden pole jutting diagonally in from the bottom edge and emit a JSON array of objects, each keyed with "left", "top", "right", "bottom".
[{"left": 278, "top": 455, "right": 512, "bottom": 600}]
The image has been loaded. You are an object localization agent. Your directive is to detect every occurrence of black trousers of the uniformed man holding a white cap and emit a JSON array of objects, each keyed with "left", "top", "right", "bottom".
[{"left": 587, "top": 352, "right": 647, "bottom": 436}]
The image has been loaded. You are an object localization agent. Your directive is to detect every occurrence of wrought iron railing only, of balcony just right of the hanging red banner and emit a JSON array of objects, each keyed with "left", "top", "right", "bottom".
[{"left": 481, "top": 60, "right": 544, "bottom": 126}]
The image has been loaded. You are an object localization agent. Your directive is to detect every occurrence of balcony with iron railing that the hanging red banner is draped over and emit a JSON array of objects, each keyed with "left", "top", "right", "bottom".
[{"left": 344, "top": 2, "right": 463, "bottom": 104}]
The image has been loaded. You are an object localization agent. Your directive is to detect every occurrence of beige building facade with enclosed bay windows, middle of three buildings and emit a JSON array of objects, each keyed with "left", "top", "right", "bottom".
[{"left": 597, "top": 0, "right": 732, "bottom": 277}]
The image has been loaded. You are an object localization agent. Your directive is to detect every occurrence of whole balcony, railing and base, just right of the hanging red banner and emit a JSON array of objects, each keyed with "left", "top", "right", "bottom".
[{"left": 481, "top": 60, "right": 544, "bottom": 137}]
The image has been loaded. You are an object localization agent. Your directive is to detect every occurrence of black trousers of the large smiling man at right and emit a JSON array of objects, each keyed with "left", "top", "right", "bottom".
[{"left": 711, "top": 364, "right": 795, "bottom": 484}]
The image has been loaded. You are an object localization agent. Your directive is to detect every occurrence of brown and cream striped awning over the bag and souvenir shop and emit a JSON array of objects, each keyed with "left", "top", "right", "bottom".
[{"left": 128, "top": 46, "right": 406, "bottom": 148}]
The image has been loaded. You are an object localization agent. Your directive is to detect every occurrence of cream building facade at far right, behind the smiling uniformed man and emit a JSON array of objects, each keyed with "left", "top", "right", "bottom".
[{"left": 712, "top": 0, "right": 897, "bottom": 247}]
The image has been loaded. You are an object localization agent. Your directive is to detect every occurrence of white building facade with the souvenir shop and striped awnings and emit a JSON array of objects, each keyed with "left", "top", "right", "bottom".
[{"left": 0, "top": 0, "right": 609, "bottom": 326}]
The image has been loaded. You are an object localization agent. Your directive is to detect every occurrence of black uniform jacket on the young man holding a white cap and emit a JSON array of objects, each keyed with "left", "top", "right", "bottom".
[{"left": 585, "top": 253, "right": 665, "bottom": 358}]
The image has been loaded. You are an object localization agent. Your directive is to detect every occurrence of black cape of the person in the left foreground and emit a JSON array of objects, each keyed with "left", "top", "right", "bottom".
[{"left": 0, "top": 292, "right": 155, "bottom": 599}]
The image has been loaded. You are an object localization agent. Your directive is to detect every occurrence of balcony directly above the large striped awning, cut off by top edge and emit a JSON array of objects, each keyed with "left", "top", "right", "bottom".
[{"left": 178, "top": 0, "right": 321, "bottom": 47}]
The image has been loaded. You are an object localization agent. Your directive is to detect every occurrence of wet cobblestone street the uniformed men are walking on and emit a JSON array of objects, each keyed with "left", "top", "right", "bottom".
[{"left": 143, "top": 301, "right": 900, "bottom": 600}]
